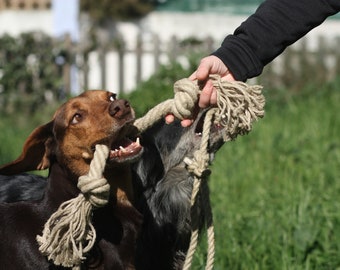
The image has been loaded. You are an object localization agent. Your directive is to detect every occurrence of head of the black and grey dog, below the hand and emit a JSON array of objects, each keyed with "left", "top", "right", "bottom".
[{"left": 134, "top": 106, "right": 224, "bottom": 191}]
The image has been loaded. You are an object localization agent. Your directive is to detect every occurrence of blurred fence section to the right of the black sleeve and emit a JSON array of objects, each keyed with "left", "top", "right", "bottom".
[{"left": 257, "top": 36, "right": 340, "bottom": 91}]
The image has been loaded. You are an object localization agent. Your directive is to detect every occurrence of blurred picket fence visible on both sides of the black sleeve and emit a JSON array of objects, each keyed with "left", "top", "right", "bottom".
[{"left": 64, "top": 33, "right": 340, "bottom": 95}]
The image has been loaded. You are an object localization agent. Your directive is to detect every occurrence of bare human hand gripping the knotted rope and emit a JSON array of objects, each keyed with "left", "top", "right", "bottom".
[{"left": 165, "top": 55, "right": 235, "bottom": 127}]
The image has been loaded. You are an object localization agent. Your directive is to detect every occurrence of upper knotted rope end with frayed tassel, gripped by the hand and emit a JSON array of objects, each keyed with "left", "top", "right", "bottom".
[{"left": 134, "top": 75, "right": 265, "bottom": 134}]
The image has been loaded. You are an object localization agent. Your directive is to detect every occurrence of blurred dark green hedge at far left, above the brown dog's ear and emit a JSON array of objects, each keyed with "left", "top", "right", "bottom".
[{"left": 0, "top": 33, "right": 66, "bottom": 114}]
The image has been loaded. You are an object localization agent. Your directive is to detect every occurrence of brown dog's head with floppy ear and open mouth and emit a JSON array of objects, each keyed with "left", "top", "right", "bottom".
[{"left": 0, "top": 90, "right": 142, "bottom": 176}]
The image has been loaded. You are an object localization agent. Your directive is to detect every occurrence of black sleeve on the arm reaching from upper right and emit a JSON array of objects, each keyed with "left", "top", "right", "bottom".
[{"left": 212, "top": 0, "right": 340, "bottom": 81}]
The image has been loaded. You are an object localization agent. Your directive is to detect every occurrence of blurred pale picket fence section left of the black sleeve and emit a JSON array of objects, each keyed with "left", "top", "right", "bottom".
[{"left": 64, "top": 35, "right": 214, "bottom": 93}]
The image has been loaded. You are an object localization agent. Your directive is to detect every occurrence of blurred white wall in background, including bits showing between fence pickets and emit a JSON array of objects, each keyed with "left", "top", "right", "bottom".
[{"left": 0, "top": 8, "right": 340, "bottom": 92}]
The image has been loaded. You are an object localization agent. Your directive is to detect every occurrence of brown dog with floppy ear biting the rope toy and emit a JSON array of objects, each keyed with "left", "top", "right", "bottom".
[{"left": 0, "top": 90, "right": 142, "bottom": 269}]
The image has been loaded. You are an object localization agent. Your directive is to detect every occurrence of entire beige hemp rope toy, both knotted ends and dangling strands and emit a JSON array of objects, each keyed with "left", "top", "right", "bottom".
[{"left": 37, "top": 76, "right": 264, "bottom": 270}]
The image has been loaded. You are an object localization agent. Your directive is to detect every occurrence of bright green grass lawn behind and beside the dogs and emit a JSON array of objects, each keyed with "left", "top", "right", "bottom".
[{"left": 0, "top": 76, "right": 340, "bottom": 270}]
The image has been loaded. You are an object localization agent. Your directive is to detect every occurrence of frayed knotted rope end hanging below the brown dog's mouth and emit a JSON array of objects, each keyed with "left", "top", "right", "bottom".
[{"left": 37, "top": 145, "right": 110, "bottom": 269}]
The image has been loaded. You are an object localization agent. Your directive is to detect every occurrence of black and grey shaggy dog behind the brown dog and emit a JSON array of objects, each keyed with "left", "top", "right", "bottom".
[{"left": 0, "top": 111, "right": 223, "bottom": 270}]
